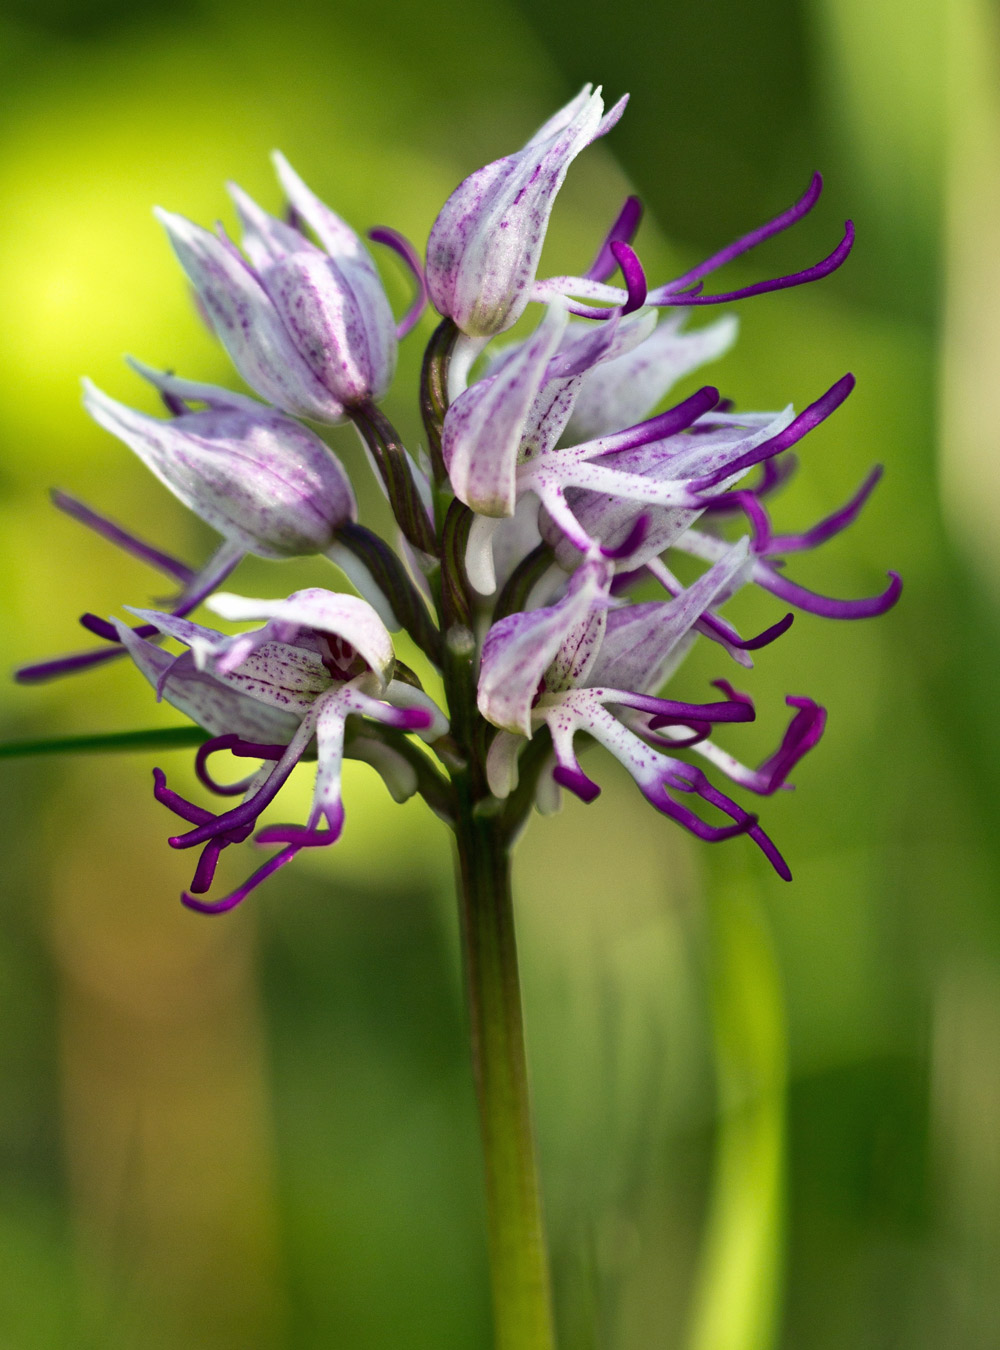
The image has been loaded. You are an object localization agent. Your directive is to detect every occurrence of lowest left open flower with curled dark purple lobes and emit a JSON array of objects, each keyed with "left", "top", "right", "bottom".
[{"left": 116, "top": 587, "right": 448, "bottom": 914}]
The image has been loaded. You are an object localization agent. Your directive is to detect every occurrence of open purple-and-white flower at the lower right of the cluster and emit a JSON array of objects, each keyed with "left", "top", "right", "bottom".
[{"left": 479, "top": 540, "right": 826, "bottom": 880}]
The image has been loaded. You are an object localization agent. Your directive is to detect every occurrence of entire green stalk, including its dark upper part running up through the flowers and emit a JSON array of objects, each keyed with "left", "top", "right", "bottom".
[{"left": 421, "top": 319, "right": 556, "bottom": 1350}]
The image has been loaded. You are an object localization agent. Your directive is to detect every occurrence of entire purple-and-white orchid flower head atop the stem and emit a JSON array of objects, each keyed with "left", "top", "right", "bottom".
[{"left": 19, "top": 85, "right": 900, "bottom": 913}]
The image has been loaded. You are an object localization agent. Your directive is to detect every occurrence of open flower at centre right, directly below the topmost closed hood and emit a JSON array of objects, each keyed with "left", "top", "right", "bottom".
[{"left": 443, "top": 304, "right": 854, "bottom": 607}]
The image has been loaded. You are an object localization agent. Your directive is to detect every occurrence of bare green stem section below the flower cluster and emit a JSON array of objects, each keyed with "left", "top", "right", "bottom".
[{"left": 455, "top": 797, "right": 555, "bottom": 1350}]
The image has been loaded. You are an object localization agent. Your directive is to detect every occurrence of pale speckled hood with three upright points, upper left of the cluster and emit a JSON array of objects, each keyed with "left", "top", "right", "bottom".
[{"left": 157, "top": 153, "right": 397, "bottom": 423}]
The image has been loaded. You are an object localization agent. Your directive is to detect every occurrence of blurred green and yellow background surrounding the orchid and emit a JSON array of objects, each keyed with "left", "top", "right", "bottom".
[{"left": 0, "top": 0, "right": 1000, "bottom": 1350}]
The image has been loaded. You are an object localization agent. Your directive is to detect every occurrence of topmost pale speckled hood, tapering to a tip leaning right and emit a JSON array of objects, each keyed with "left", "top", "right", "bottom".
[{"left": 426, "top": 85, "right": 628, "bottom": 338}]
